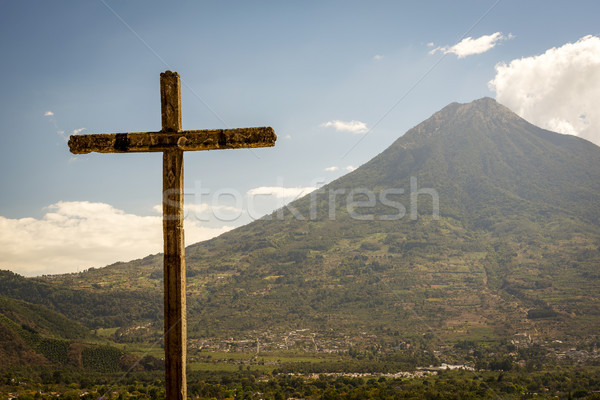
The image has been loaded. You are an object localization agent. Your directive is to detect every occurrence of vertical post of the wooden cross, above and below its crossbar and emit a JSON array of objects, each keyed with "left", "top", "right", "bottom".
[{"left": 160, "top": 71, "right": 187, "bottom": 400}]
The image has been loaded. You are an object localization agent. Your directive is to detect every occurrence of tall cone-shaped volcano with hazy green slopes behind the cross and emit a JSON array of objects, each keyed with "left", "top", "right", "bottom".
[{"left": 0, "top": 98, "right": 600, "bottom": 343}]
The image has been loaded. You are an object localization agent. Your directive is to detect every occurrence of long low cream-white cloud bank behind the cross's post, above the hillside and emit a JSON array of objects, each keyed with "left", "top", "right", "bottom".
[{"left": 0, "top": 202, "right": 232, "bottom": 275}]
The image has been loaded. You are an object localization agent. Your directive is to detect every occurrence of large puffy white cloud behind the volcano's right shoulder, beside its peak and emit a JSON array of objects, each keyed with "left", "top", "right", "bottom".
[{"left": 489, "top": 35, "right": 600, "bottom": 145}]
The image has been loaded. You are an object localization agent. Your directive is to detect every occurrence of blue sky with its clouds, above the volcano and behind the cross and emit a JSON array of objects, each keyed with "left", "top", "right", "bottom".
[{"left": 0, "top": 0, "right": 600, "bottom": 275}]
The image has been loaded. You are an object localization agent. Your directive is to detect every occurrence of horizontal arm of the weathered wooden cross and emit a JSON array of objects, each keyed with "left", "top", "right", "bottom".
[{"left": 69, "top": 127, "right": 277, "bottom": 154}]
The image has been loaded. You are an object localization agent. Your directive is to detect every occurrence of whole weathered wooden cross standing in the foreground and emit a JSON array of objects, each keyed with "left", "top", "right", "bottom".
[{"left": 69, "top": 71, "right": 277, "bottom": 400}]
